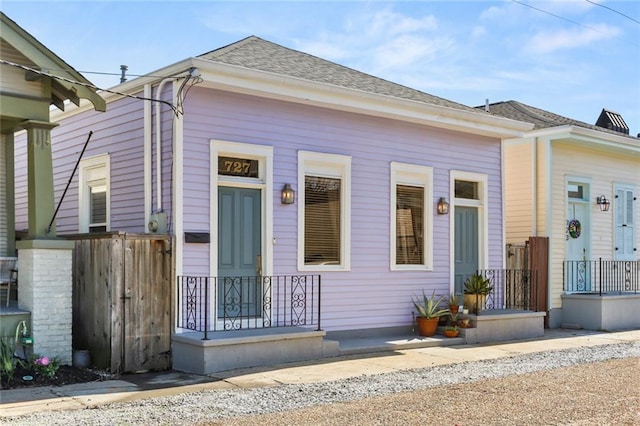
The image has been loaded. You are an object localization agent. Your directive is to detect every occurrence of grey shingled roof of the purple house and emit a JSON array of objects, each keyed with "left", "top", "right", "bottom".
[{"left": 198, "top": 36, "right": 477, "bottom": 112}]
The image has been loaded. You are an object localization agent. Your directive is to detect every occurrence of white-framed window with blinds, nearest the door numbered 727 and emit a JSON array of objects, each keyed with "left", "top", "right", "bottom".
[{"left": 298, "top": 151, "right": 351, "bottom": 270}]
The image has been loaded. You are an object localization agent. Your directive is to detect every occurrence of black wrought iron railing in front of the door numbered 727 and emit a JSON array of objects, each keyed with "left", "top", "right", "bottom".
[{"left": 177, "top": 275, "right": 321, "bottom": 340}]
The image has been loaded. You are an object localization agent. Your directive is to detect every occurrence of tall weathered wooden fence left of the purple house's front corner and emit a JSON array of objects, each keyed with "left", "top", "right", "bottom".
[{"left": 65, "top": 232, "right": 173, "bottom": 373}]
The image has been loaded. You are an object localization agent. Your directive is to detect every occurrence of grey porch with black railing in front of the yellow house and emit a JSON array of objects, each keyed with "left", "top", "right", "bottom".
[{"left": 561, "top": 259, "right": 640, "bottom": 330}]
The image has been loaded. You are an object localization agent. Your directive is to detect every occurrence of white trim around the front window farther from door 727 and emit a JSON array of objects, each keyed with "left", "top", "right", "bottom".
[{"left": 389, "top": 162, "right": 433, "bottom": 271}]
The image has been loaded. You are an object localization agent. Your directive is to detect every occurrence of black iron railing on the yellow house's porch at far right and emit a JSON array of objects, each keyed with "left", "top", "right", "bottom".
[{"left": 562, "top": 258, "right": 640, "bottom": 295}]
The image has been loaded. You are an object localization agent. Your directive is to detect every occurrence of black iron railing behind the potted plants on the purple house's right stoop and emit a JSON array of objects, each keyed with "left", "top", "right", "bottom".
[{"left": 476, "top": 269, "right": 538, "bottom": 313}]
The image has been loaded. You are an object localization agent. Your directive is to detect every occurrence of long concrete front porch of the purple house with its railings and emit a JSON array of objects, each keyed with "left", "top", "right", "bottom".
[{"left": 171, "top": 270, "right": 545, "bottom": 374}]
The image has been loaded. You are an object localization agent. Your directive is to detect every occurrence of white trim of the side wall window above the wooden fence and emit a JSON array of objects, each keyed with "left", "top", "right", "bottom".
[{"left": 78, "top": 153, "right": 111, "bottom": 233}]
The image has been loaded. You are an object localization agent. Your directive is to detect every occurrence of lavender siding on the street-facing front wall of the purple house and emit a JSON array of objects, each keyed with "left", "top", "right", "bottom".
[{"left": 177, "top": 88, "right": 503, "bottom": 330}]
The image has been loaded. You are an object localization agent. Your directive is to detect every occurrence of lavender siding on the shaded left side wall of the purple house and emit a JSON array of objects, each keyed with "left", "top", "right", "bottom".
[{"left": 15, "top": 91, "right": 173, "bottom": 234}]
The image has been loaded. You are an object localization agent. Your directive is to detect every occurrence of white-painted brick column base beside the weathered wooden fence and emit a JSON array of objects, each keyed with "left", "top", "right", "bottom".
[{"left": 16, "top": 239, "right": 74, "bottom": 365}]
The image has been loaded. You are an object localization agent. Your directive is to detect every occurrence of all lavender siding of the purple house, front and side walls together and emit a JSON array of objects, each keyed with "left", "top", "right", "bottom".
[{"left": 16, "top": 86, "right": 504, "bottom": 330}]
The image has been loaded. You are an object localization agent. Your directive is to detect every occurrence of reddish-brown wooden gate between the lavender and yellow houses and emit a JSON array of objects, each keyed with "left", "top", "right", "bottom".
[{"left": 506, "top": 237, "right": 549, "bottom": 327}]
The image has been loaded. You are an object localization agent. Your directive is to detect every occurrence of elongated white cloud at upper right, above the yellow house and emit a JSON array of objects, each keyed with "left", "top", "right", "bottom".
[{"left": 525, "top": 24, "right": 620, "bottom": 54}]
